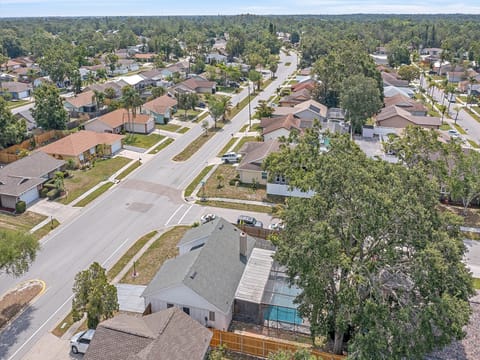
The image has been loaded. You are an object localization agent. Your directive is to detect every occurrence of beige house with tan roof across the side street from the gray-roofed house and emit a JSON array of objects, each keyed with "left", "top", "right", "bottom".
[{"left": 237, "top": 138, "right": 281, "bottom": 185}]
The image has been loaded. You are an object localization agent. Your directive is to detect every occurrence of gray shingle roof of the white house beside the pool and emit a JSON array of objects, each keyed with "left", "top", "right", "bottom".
[{"left": 142, "top": 218, "right": 255, "bottom": 314}]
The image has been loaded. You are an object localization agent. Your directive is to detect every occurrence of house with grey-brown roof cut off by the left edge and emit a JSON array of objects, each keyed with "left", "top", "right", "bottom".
[{"left": 0, "top": 152, "right": 65, "bottom": 209}]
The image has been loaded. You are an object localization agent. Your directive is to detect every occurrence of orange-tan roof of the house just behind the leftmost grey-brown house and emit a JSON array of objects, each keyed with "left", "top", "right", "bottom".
[{"left": 39, "top": 130, "right": 123, "bottom": 156}]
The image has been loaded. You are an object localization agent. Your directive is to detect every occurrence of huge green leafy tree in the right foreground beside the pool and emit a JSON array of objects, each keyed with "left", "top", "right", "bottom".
[{"left": 265, "top": 127, "right": 473, "bottom": 359}]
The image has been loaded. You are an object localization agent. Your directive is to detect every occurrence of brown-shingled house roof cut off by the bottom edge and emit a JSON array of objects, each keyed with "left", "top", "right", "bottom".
[{"left": 84, "top": 307, "right": 213, "bottom": 360}]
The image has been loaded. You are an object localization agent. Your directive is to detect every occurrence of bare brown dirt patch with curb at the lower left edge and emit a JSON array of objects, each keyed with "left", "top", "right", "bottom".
[{"left": 0, "top": 280, "right": 43, "bottom": 329}]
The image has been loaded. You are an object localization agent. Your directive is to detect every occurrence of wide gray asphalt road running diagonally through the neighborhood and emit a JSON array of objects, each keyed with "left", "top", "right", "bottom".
[{"left": 0, "top": 53, "right": 297, "bottom": 360}]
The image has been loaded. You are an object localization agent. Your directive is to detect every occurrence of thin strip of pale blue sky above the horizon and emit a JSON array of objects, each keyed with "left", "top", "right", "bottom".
[{"left": 0, "top": 0, "right": 480, "bottom": 17}]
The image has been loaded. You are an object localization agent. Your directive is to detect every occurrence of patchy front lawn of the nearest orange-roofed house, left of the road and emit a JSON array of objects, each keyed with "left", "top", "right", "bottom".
[{"left": 58, "top": 156, "right": 131, "bottom": 204}]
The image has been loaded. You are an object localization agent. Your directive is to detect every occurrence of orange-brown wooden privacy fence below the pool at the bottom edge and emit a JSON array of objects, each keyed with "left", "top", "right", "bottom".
[{"left": 210, "top": 329, "right": 346, "bottom": 360}]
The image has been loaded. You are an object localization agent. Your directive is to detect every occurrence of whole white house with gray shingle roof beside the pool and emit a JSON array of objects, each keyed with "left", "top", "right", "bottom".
[{"left": 142, "top": 218, "right": 255, "bottom": 330}]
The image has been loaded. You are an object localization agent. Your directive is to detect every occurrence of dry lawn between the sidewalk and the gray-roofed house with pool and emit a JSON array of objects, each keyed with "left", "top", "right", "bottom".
[{"left": 120, "top": 226, "right": 190, "bottom": 285}]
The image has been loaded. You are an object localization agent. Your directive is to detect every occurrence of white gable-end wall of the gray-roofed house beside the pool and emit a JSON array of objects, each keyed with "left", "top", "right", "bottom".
[{"left": 145, "top": 285, "right": 232, "bottom": 331}]
